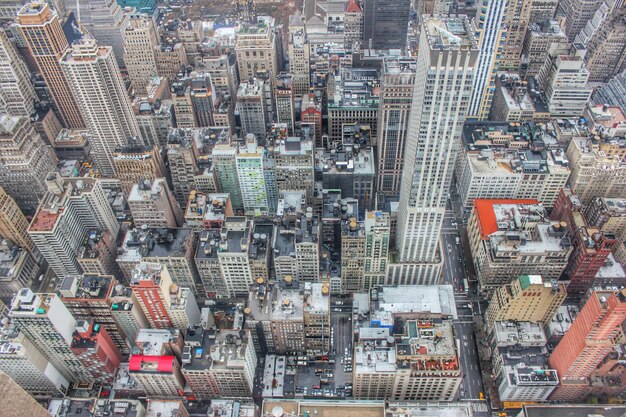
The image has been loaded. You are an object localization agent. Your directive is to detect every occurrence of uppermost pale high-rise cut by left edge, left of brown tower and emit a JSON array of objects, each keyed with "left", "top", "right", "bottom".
[{"left": 0, "top": 31, "right": 36, "bottom": 117}]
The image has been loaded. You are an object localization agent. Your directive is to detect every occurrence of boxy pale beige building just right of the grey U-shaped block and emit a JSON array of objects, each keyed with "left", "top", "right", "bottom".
[{"left": 127, "top": 178, "right": 183, "bottom": 228}]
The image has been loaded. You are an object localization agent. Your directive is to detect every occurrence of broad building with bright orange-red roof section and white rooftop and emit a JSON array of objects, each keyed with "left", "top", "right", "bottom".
[{"left": 467, "top": 199, "right": 572, "bottom": 294}]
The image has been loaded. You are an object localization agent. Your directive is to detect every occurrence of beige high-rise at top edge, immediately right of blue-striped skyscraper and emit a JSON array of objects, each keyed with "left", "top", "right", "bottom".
[{"left": 494, "top": 0, "right": 533, "bottom": 71}]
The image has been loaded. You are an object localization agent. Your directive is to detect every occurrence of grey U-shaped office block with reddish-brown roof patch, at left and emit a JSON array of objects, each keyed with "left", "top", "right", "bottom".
[{"left": 28, "top": 173, "right": 119, "bottom": 277}]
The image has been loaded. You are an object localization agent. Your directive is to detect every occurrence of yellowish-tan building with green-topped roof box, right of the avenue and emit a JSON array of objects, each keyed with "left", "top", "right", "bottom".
[{"left": 487, "top": 275, "right": 567, "bottom": 325}]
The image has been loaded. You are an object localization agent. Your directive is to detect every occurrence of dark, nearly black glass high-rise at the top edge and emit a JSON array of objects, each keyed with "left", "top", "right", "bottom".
[{"left": 362, "top": 0, "right": 411, "bottom": 49}]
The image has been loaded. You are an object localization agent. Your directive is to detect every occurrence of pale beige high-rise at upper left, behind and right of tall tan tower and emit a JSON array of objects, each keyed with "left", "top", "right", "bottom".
[{"left": 122, "top": 14, "right": 158, "bottom": 94}]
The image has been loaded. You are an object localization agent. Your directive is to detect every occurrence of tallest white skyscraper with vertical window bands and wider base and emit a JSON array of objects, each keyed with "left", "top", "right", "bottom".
[{"left": 390, "top": 16, "right": 479, "bottom": 284}]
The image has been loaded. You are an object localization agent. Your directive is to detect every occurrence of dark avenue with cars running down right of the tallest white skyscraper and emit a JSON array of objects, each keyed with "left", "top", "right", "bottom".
[{"left": 441, "top": 188, "right": 488, "bottom": 416}]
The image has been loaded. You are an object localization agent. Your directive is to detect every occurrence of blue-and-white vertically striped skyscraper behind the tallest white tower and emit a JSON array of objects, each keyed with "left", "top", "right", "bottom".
[{"left": 468, "top": 0, "right": 508, "bottom": 120}]
